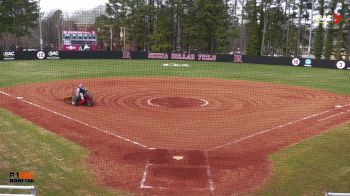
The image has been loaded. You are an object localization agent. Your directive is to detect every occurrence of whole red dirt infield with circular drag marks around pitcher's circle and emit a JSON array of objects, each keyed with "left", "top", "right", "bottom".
[{"left": 0, "top": 78, "right": 350, "bottom": 195}]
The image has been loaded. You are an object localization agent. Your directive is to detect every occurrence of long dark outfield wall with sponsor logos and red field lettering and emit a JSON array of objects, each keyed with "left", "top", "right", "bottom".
[{"left": 0, "top": 51, "right": 350, "bottom": 70}]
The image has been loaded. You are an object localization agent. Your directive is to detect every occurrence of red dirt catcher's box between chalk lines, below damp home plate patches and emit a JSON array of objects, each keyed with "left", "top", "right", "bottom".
[{"left": 144, "top": 165, "right": 209, "bottom": 189}]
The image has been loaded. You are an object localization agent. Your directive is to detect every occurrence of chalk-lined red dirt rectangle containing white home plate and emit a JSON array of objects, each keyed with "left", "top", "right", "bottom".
[{"left": 140, "top": 149, "right": 213, "bottom": 191}]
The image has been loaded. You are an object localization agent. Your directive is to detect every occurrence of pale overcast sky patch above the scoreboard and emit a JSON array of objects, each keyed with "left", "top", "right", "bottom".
[{"left": 40, "top": 0, "right": 108, "bottom": 13}]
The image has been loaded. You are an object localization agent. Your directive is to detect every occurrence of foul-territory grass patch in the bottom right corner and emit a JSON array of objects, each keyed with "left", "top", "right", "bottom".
[{"left": 255, "top": 125, "right": 350, "bottom": 196}]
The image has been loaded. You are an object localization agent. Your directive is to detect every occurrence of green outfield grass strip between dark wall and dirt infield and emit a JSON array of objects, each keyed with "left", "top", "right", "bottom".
[{"left": 0, "top": 60, "right": 350, "bottom": 94}]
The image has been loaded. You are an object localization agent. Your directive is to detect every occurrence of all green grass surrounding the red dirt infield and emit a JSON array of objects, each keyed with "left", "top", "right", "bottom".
[{"left": 0, "top": 60, "right": 350, "bottom": 195}]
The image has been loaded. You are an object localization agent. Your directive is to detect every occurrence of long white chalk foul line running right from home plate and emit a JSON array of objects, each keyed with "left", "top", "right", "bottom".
[{"left": 208, "top": 104, "right": 350, "bottom": 152}]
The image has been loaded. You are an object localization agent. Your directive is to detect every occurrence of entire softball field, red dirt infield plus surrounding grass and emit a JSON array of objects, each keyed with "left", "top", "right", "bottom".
[{"left": 0, "top": 60, "right": 350, "bottom": 195}]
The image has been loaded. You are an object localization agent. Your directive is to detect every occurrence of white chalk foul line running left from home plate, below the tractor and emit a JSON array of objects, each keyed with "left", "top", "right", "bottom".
[{"left": 0, "top": 91, "right": 151, "bottom": 149}]
